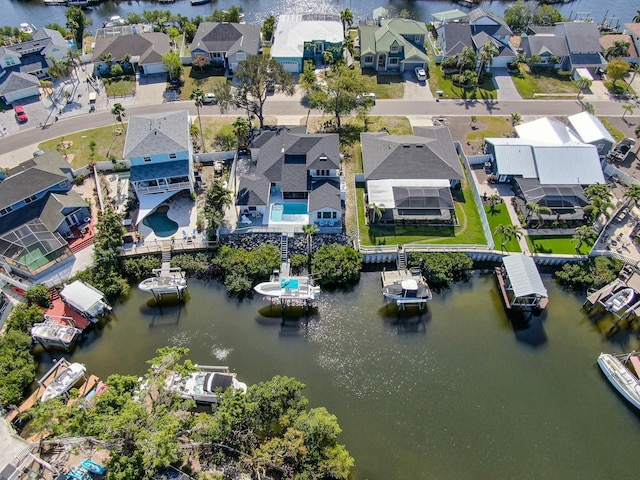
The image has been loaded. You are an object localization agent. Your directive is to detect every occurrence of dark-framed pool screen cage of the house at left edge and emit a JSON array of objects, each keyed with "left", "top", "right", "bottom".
[{"left": 0, "top": 219, "right": 68, "bottom": 273}]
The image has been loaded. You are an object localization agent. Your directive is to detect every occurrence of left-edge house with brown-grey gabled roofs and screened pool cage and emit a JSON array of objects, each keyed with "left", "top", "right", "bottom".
[{"left": 0, "top": 151, "right": 90, "bottom": 279}]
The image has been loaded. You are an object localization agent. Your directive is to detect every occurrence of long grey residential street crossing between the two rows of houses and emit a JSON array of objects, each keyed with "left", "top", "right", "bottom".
[{"left": 0, "top": 99, "right": 626, "bottom": 155}]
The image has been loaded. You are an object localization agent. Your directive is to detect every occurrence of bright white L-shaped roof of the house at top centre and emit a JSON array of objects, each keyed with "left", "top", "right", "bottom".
[{"left": 271, "top": 15, "right": 344, "bottom": 58}]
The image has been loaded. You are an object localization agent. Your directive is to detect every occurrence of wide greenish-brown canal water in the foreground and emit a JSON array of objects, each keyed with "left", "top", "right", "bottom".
[{"left": 37, "top": 273, "right": 640, "bottom": 480}]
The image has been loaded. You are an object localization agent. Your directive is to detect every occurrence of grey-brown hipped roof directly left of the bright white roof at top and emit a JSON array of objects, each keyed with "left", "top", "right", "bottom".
[{"left": 191, "top": 22, "right": 260, "bottom": 56}]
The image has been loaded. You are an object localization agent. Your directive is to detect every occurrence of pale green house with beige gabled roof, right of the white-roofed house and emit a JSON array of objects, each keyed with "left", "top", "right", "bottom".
[{"left": 358, "top": 18, "right": 429, "bottom": 73}]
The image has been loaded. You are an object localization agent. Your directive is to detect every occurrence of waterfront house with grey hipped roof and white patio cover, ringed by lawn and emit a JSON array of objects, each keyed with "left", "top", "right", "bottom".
[{"left": 360, "top": 127, "right": 464, "bottom": 225}]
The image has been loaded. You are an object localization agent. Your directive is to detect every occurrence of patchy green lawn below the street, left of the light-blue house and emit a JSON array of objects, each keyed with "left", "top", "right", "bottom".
[{"left": 38, "top": 123, "right": 127, "bottom": 168}]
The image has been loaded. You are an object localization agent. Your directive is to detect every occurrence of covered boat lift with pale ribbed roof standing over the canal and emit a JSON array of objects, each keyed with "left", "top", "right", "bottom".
[{"left": 496, "top": 254, "right": 549, "bottom": 310}]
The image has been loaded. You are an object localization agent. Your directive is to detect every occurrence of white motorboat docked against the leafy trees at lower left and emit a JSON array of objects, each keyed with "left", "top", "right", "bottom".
[{"left": 165, "top": 365, "right": 247, "bottom": 403}]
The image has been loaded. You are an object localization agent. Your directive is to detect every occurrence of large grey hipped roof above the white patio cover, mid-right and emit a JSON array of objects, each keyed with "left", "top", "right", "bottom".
[{"left": 360, "top": 127, "right": 464, "bottom": 181}]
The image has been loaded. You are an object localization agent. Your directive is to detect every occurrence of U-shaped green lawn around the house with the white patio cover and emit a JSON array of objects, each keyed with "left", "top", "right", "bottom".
[{"left": 356, "top": 173, "right": 486, "bottom": 245}]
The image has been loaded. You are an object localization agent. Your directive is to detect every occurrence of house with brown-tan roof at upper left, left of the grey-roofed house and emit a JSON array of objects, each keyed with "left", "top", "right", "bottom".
[{"left": 93, "top": 25, "right": 171, "bottom": 75}]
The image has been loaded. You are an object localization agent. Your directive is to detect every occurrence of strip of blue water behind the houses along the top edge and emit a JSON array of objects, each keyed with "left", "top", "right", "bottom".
[{"left": 0, "top": 0, "right": 638, "bottom": 32}]
